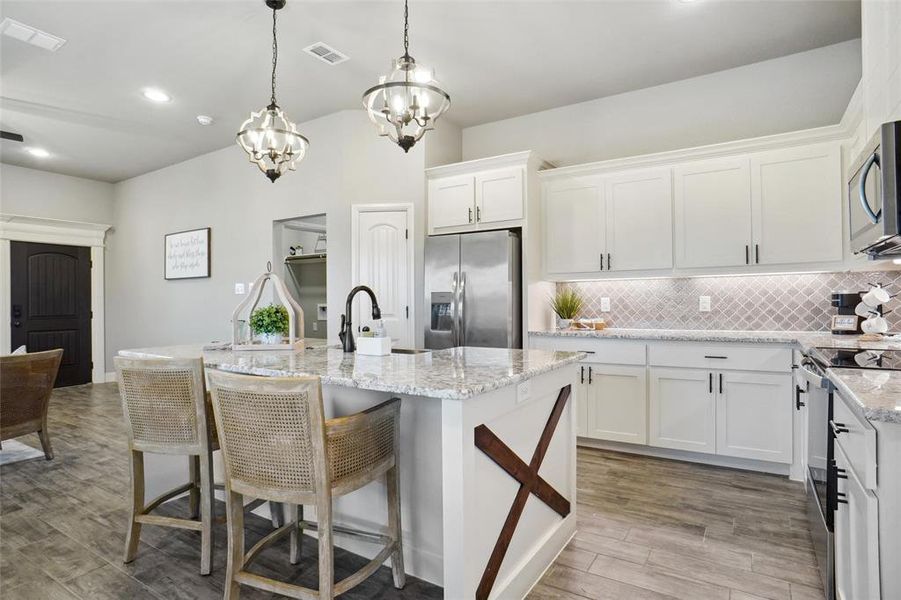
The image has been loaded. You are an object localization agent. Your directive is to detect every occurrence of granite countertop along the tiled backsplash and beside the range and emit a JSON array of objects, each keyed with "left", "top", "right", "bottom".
[{"left": 529, "top": 328, "right": 901, "bottom": 424}]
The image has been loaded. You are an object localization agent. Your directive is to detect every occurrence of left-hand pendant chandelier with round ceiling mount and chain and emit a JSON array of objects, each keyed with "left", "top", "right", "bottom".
[{"left": 236, "top": 0, "right": 310, "bottom": 183}]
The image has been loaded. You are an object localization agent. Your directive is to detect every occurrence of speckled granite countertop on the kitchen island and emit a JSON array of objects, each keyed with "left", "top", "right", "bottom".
[{"left": 119, "top": 344, "right": 585, "bottom": 400}]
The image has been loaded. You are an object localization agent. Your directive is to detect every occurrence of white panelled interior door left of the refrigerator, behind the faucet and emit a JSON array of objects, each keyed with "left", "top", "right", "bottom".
[{"left": 352, "top": 205, "right": 413, "bottom": 347}]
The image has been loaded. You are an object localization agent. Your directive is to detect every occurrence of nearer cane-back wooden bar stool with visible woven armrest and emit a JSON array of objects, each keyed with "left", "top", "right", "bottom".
[{"left": 209, "top": 371, "right": 405, "bottom": 600}]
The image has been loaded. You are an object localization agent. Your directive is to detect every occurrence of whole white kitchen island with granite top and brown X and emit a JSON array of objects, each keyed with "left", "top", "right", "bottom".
[{"left": 120, "top": 345, "right": 584, "bottom": 600}]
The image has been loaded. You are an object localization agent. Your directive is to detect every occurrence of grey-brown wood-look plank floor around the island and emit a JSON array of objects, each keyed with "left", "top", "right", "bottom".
[{"left": 0, "top": 384, "right": 822, "bottom": 600}]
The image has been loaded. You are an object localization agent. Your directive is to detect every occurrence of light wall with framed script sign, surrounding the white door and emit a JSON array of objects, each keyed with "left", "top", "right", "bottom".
[{"left": 107, "top": 111, "right": 425, "bottom": 364}]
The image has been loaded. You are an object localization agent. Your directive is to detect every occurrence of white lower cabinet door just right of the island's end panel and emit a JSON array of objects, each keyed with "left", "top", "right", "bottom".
[{"left": 585, "top": 364, "right": 648, "bottom": 444}]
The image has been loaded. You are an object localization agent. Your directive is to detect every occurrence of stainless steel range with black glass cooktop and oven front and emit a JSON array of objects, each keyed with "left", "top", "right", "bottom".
[{"left": 796, "top": 348, "right": 901, "bottom": 600}]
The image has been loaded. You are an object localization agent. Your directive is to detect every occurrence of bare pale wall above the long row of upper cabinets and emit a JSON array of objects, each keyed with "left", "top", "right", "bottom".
[{"left": 463, "top": 40, "right": 861, "bottom": 166}]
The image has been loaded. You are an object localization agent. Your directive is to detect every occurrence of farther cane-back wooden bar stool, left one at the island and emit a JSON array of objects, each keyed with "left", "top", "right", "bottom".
[{"left": 114, "top": 356, "right": 217, "bottom": 575}]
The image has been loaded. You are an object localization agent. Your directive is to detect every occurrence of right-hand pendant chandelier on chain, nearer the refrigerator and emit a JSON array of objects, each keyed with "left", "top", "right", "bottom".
[{"left": 363, "top": 0, "right": 450, "bottom": 152}]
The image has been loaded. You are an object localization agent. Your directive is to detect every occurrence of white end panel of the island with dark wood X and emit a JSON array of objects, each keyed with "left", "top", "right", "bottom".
[{"left": 441, "top": 368, "right": 578, "bottom": 598}]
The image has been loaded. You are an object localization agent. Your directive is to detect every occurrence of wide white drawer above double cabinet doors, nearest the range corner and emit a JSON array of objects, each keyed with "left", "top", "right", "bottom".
[{"left": 648, "top": 343, "right": 791, "bottom": 372}]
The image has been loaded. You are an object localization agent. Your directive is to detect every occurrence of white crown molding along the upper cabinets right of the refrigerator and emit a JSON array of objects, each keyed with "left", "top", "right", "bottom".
[{"left": 538, "top": 119, "right": 854, "bottom": 181}]
